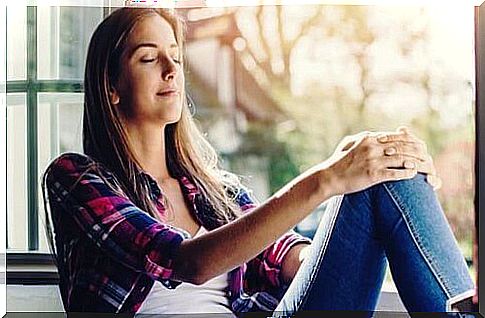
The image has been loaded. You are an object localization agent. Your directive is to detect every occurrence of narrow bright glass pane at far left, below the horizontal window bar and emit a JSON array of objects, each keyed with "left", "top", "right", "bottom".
[{"left": 7, "top": 94, "right": 27, "bottom": 250}]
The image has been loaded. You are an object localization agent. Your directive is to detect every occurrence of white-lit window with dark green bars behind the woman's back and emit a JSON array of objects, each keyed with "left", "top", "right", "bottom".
[{"left": 7, "top": 4, "right": 107, "bottom": 253}]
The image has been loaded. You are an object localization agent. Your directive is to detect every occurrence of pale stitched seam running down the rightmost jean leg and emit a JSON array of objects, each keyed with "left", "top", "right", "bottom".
[{"left": 383, "top": 184, "right": 451, "bottom": 298}]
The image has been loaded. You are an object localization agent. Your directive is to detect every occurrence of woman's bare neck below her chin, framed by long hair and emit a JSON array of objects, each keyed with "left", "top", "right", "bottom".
[{"left": 126, "top": 122, "right": 172, "bottom": 182}]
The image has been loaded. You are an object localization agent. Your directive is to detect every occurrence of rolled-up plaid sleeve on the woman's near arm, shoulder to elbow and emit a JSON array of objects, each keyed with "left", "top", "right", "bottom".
[{"left": 45, "top": 153, "right": 189, "bottom": 288}]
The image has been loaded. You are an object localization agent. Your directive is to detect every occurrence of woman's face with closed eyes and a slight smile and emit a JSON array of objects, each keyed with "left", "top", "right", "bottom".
[{"left": 111, "top": 15, "right": 184, "bottom": 126}]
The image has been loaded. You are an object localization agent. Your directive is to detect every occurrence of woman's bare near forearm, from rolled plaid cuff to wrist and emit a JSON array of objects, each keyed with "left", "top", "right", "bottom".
[{"left": 173, "top": 171, "right": 330, "bottom": 283}]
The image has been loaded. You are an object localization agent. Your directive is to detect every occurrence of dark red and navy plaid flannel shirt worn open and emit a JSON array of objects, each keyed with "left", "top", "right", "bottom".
[{"left": 46, "top": 153, "right": 310, "bottom": 313}]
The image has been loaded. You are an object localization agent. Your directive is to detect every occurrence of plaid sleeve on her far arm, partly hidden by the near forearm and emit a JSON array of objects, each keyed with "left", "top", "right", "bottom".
[{"left": 233, "top": 189, "right": 311, "bottom": 290}]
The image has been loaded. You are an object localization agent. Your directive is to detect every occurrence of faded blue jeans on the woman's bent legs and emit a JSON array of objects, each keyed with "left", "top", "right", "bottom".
[{"left": 274, "top": 174, "right": 474, "bottom": 316}]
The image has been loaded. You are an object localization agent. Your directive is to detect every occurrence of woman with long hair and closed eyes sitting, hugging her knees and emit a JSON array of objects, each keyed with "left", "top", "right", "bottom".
[{"left": 43, "top": 8, "right": 474, "bottom": 316}]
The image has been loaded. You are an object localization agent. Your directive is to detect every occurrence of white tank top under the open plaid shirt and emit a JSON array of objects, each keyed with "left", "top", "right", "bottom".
[{"left": 137, "top": 226, "right": 236, "bottom": 318}]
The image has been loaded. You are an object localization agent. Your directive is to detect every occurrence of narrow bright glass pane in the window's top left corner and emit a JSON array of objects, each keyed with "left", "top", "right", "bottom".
[{"left": 7, "top": 5, "right": 27, "bottom": 80}]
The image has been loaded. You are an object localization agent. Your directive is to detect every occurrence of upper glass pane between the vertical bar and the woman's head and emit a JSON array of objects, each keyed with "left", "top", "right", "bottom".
[{"left": 37, "top": 6, "right": 103, "bottom": 79}]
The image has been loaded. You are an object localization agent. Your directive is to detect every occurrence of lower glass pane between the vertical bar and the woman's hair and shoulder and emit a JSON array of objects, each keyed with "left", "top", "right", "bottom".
[{"left": 37, "top": 93, "right": 83, "bottom": 251}]
